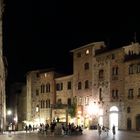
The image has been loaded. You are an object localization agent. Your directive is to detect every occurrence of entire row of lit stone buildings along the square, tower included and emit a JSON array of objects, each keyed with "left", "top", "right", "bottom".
[{"left": 27, "top": 42, "right": 140, "bottom": 130}]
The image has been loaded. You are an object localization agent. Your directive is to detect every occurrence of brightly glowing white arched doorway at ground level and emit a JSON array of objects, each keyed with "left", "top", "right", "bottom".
[{"left": 109, "top": 106, "right": 119, "bottom": 130}]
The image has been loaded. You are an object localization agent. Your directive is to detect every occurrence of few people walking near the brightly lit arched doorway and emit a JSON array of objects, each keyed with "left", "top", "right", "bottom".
[{"left": 97, "top": 124, "right": 116, "bottom": 136}]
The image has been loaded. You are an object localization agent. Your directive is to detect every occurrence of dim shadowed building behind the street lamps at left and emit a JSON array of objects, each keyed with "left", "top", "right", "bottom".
[{"left": 6, "top": 82, "right": 27, "bottom": 130}]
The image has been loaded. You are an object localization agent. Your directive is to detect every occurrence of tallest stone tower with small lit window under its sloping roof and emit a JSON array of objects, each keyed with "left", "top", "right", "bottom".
[{"left": 71, "top": 42, "right": 104, "bottom": 127}]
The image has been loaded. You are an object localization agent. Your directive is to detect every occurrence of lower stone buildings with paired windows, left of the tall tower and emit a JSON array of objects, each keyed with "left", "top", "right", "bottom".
[{"left": 25, "top": 69, "right": 73, "bottom": 125}]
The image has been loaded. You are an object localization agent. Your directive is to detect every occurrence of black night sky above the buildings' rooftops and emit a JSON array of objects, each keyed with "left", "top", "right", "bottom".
[{"left": 3, "top": 0, "right": 140, "bottom": 82}]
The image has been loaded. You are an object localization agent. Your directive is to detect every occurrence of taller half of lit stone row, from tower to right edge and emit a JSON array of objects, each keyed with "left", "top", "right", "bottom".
[{"left": 72, "top": 42, "right": 140, "bottom": 130}]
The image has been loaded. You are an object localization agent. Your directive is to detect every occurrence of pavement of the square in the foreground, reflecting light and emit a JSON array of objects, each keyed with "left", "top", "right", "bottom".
[{"left": 0, "top": 130, "right": 140, "bottom": 140}]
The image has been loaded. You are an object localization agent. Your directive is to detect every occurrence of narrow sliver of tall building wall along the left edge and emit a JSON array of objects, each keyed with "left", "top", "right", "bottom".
[{"left": 0, "top": 0, "right": 6, "bottom": 131}]
